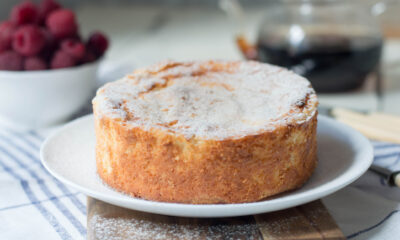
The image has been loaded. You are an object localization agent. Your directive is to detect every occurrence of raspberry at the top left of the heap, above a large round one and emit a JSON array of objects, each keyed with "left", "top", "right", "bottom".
[{"left": 10, "top": 1, "right": 39, "bottom": 25}]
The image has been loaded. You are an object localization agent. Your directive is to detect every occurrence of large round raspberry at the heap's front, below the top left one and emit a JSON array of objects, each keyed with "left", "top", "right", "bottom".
[{"left": 12, "top": 25, "right": 46, "bottom": 56}]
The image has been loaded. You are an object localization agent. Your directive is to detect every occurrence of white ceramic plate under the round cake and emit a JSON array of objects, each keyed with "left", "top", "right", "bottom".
[{"left": 41, "top": 115, "right": 373, "bottom": 217}]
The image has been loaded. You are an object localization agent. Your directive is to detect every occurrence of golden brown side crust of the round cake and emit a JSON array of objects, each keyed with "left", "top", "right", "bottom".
[{"left": 93, "top": 60, "right": 317, "bottom": 204}]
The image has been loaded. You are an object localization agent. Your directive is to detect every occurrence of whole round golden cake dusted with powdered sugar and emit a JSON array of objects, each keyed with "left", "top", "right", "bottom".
[{"left": 93, "top": 61, "right": 318, "bottom": 204}]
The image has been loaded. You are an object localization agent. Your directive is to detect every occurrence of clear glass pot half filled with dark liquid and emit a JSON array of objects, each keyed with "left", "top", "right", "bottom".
[{"left": 238, "top": 0, "right": 383, "bottom": 92}]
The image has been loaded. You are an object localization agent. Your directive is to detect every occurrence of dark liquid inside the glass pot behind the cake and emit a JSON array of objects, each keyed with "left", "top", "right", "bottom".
[{"left": 257, "top": 35, "right": 382, "bottom": 92}]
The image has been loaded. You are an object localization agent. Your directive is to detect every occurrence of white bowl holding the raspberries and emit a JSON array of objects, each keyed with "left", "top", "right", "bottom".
[{"left": 0, "top": 61, "right": 99, "bottom": 129}]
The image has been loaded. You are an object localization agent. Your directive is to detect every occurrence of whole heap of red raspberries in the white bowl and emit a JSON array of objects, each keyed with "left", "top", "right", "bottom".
[{"left": 0, "top": 0, "right": 108, "bottom": 71}]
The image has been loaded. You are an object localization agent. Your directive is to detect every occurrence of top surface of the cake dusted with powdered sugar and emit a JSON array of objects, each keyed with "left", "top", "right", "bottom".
[{"left": 93, "top": 61, "right": 317, "bottom": 139}]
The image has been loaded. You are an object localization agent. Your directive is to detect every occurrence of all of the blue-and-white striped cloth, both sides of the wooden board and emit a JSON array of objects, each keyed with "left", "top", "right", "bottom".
[{"left": 0, "top": 127, "right": 400, "bottom": 240}]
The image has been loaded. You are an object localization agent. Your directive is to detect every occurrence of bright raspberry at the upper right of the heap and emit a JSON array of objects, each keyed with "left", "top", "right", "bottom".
[{"left": 46, "top": 9, "right": 78, "bottom": 39}]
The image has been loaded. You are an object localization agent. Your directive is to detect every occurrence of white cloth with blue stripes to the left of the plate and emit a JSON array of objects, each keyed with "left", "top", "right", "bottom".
[{"left": 0, "top": 128, "right": 86, "bottom": 239}]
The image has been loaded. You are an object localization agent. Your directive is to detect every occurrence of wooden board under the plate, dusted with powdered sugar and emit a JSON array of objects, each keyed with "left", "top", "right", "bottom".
[{"left": 87, "top": 197, "right": 345, "bottom": 240}]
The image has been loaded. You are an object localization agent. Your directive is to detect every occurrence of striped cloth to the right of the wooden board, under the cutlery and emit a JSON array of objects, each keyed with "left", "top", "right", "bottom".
[{"left": 323, "top": 142, "right": 400, "bottom": 240}]
